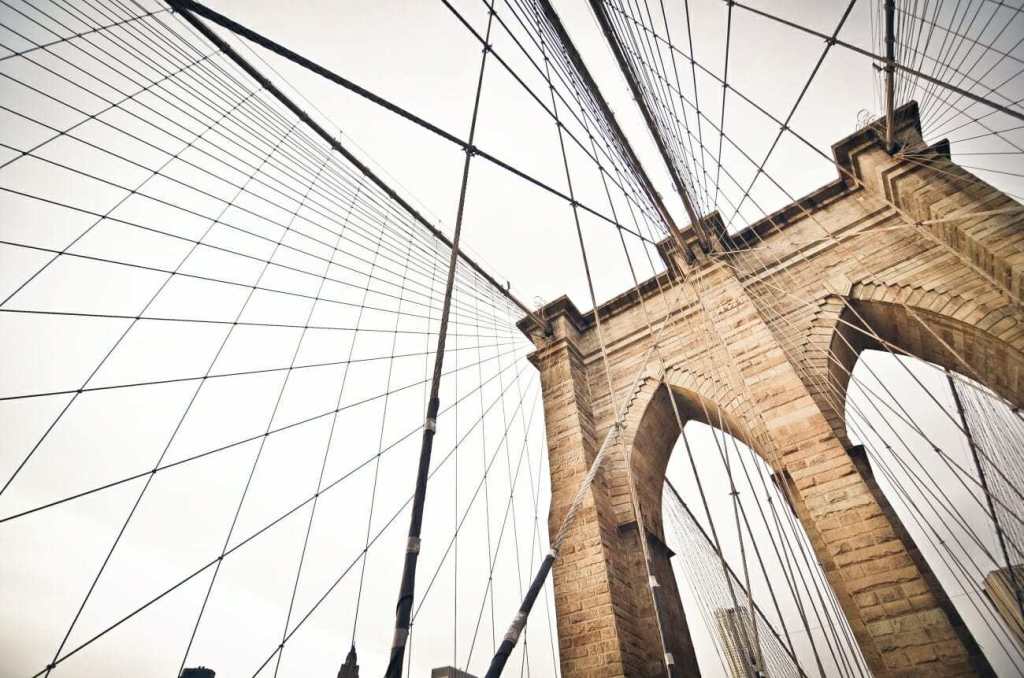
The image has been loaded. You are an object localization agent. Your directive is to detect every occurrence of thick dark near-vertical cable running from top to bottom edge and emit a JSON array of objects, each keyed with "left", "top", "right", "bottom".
[{"left": 384, "top": 0, "right": 495, "bottom": 678}]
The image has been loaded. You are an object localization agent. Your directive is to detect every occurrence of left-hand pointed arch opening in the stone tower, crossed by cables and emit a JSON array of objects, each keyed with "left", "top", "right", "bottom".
[{"left": 631, "top": 383, "right": 869, "bottom": 677}]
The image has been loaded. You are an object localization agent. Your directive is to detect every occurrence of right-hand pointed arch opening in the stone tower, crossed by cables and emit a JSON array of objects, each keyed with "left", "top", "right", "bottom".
[{"left": 844, "top": 348, "right": 1024, "bottom": 675}]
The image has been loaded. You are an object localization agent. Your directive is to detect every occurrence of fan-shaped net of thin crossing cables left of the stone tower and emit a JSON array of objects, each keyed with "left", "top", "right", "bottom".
[{"left": 0, "top": 0, "right": 554, "bottom": 675}]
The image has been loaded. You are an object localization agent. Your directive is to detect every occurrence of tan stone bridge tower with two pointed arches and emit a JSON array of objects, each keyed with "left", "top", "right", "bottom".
[{"left": 520, "top": 103, "right": 1024, "bottom": 678}]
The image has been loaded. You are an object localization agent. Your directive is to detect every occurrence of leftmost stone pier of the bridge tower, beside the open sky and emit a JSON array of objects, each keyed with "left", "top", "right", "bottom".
[{"left": 530, "top": 305, "right": 698, "bottom": 676}]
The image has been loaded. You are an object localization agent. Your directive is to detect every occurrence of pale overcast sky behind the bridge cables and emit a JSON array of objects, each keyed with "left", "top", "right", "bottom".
[{"left": 0, "top": 0, "right": 1024, "bottom": 678}]
